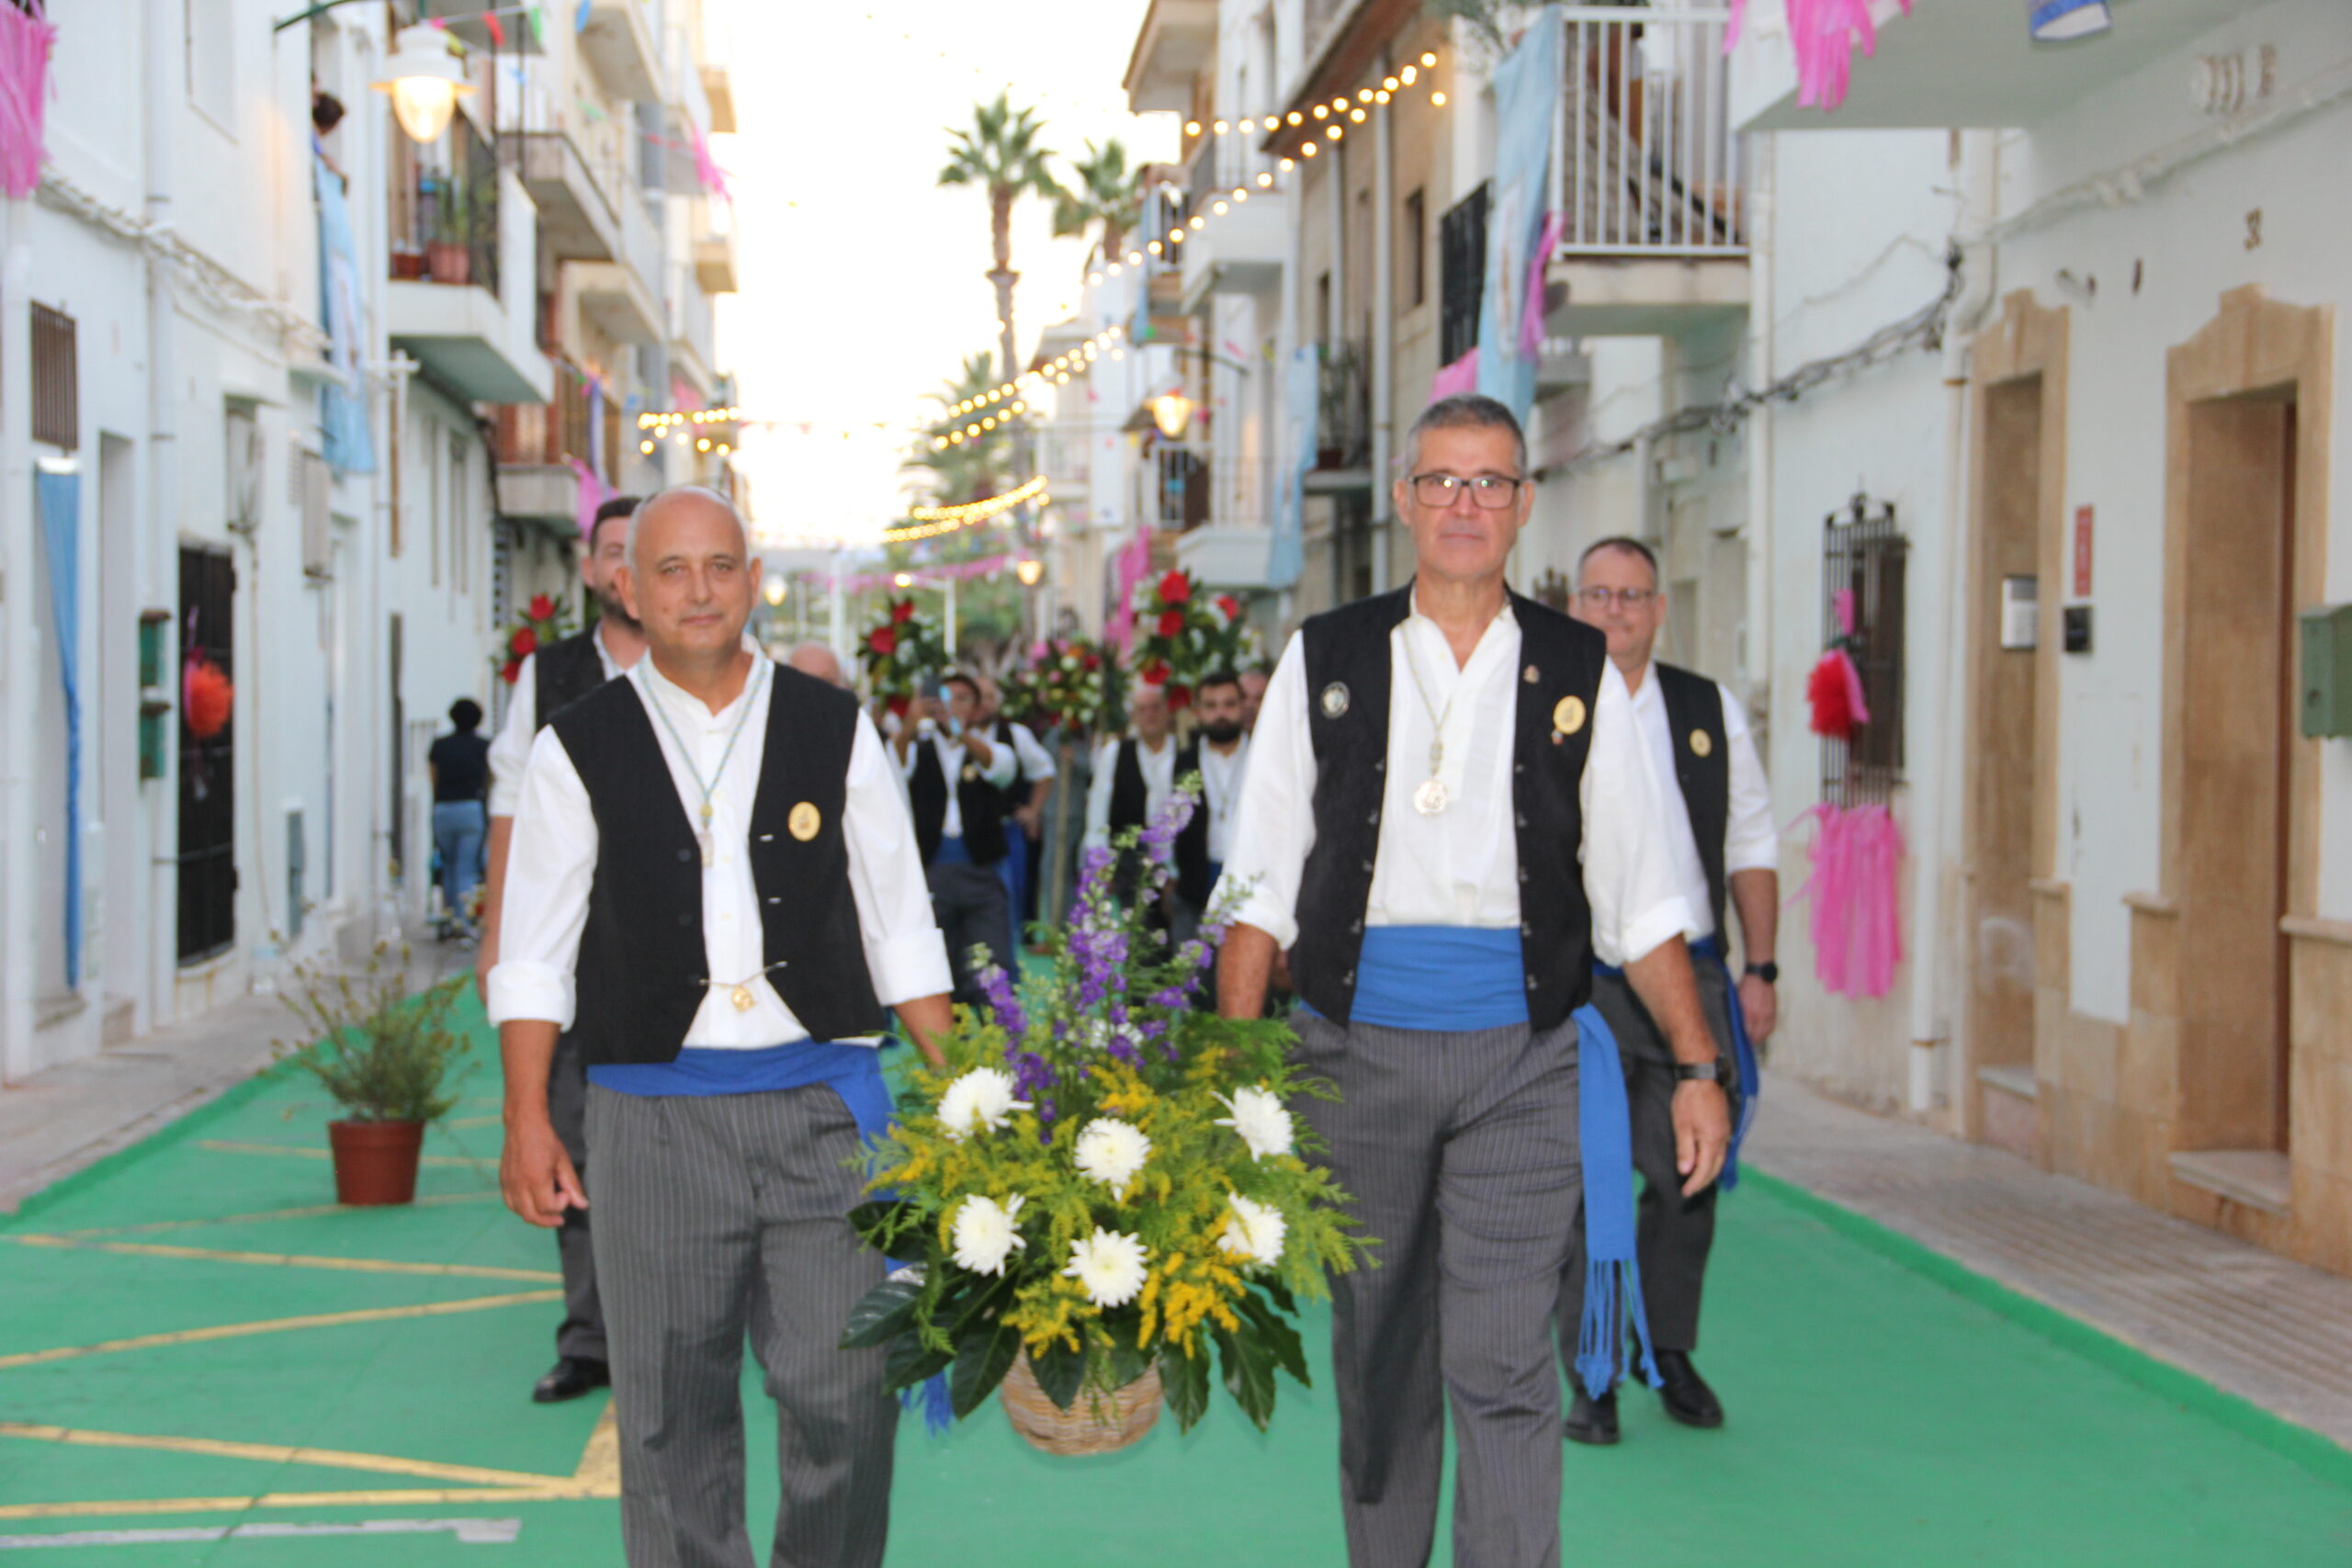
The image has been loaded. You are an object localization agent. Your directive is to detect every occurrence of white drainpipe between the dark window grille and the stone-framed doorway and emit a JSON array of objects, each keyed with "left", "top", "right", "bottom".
[{"left": 1907, "top": 131, "right": 1996, "bottom": 1114}]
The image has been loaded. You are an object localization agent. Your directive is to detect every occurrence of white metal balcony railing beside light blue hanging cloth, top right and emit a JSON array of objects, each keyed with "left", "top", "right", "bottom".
[{"left": 1553, "top": 5, "right": 1747, "bottom": 256}]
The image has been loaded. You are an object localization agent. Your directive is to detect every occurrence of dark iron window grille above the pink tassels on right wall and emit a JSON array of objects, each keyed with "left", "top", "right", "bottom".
[{"left": 1820, "top": 493, "right": 1910, "bottom": 807}]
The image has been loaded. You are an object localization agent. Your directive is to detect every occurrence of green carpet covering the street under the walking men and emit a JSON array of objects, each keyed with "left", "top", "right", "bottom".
[{"left": 0, "top": 987, "right": 2352, "bottom": 1568}]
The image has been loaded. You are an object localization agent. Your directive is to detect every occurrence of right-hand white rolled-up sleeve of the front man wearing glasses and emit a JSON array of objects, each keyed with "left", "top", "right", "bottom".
[{"left": 1578, "top": 665, "right": 1693, "bottom": 968}]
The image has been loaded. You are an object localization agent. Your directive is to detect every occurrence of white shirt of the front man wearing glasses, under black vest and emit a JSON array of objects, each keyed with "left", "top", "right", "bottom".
[{"left": 1218, "top": 602, "right": 1691, "bottom": 966}]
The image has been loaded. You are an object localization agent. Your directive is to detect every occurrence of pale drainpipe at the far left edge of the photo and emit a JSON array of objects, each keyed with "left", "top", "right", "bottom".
[{"left": 0, "top": 200, "right": 42, "bottom": 1081}]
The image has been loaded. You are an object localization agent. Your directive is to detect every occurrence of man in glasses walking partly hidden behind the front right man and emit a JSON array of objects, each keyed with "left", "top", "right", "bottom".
[{"left": 1559, "top": 538, "right": 1781, "bottom": 1443}]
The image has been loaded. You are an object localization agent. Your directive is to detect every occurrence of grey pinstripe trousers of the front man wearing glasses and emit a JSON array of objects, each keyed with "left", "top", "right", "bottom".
[{"left": 1294, "top": 1013, "right": 1583, "bottom": 1568}]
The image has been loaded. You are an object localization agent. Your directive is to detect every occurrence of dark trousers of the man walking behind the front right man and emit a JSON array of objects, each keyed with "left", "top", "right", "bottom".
[{"left": 1559, "top": 962, "right": 1731, "bottom": 1366}]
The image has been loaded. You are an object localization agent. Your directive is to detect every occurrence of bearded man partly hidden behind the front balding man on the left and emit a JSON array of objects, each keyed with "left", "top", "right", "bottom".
[{"left": 475, "top": 496, "right": 644, "bottom": 1404}]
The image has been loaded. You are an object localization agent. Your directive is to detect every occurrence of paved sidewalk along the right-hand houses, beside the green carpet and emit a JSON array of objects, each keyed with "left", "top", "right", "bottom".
[{"left": 1747, "top": 1075, "right": 2352, "bottom": 1448}]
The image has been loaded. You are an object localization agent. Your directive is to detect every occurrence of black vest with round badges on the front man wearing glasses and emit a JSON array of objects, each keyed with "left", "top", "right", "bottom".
[{"left": 1291, "top": 583, "right": 1609, "bottom": 1030}]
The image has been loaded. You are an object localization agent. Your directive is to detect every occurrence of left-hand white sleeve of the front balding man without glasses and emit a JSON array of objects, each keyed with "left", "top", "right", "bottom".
[{"left": 484, "top": 728, "right": 597, "bottom": 1030}]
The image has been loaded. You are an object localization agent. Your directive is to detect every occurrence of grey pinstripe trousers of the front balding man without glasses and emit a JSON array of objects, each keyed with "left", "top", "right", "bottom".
[{"left": 588, "top": 1084, "right": 899, "bottom": 1568}]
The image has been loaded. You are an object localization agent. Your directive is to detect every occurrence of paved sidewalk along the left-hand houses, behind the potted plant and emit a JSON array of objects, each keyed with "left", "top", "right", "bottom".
[{"left": 0, "top": 941, "right": 473, "bottom": 1213}]
